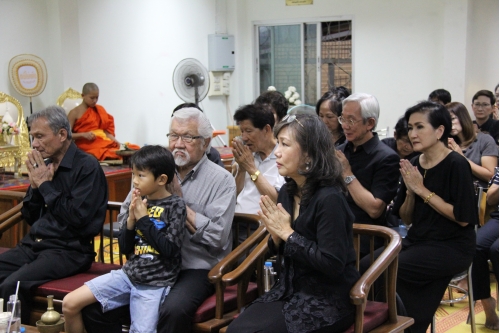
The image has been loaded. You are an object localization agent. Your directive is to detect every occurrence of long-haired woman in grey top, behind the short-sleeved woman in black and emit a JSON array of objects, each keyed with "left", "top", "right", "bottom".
[{"left": 445, "top": 102, "right": 498, "bottom": 187}]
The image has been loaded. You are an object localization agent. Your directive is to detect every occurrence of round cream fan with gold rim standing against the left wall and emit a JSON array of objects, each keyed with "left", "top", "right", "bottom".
[{"left": 9, "top": 54, "right": 47, "bottom": 97}]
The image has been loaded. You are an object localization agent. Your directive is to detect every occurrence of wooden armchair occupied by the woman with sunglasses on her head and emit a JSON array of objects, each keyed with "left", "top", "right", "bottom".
[{"left": 219, "top": 223, "right": 414, "bottom": 333}]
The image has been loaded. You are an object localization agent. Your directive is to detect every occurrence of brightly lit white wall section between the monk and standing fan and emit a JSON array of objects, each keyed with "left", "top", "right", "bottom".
[{"left": 73, "top": 0, "right": 226, "bottom": 145}]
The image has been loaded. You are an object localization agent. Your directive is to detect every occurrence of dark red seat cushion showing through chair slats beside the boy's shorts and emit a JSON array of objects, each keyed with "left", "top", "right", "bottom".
[{"left": 193, "top": 282, "right": 259, "bottom": 323}]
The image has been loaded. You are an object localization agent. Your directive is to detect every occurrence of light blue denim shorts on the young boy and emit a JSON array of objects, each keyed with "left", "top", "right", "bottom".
[{"left": 85, "top": 269, "right": 170, "bottom": 333}]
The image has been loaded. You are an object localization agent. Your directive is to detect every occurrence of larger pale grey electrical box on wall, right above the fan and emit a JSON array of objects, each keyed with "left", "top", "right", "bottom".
[{"left": 208, "top": 34, "right": 235, "bottom": 72}]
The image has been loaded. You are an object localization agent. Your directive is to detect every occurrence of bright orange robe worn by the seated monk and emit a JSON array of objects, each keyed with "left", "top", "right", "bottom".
[{"left": 73, "top": 105, "right": 131, "bottom": 161}]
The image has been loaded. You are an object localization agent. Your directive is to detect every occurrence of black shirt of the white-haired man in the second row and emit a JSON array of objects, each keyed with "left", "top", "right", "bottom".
[{"left": 338, "top": 133, "right": 400, "bottom": 225}]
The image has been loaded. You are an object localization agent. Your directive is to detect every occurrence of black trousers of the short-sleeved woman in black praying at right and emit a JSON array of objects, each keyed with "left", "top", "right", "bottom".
[{"left": 360, "top": 239, "right": 473, "bottom": 333}]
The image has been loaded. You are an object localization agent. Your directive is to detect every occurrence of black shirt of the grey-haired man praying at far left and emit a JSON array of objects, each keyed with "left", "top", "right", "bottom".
[{"left": 21, "top": 142, "right": 108, "bottom": 253}]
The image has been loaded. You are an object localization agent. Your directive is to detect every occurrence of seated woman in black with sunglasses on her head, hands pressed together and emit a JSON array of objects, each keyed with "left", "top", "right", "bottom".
[{"left": 228, "top": 115, "right": 359, "bottom": 333}]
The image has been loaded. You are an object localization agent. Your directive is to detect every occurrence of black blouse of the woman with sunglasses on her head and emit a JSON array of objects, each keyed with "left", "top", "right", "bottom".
[{"left": 256, "top": 186, "right": 359, "bottom": 332}]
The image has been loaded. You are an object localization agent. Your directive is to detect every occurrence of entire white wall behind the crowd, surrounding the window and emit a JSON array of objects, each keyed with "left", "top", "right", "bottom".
[{"left": 0, "top": 0, "right": 499, "bottom": 145}]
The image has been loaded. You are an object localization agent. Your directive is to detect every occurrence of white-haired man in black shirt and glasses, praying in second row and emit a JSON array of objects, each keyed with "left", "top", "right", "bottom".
[{"left": 337, "top": 93, "right": 399, "bottom": 254}]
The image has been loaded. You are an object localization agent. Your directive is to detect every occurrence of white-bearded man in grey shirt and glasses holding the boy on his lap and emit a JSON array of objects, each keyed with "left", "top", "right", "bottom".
[{"left": 82, "top": 108, "right": 236, "bottom": 333}]
